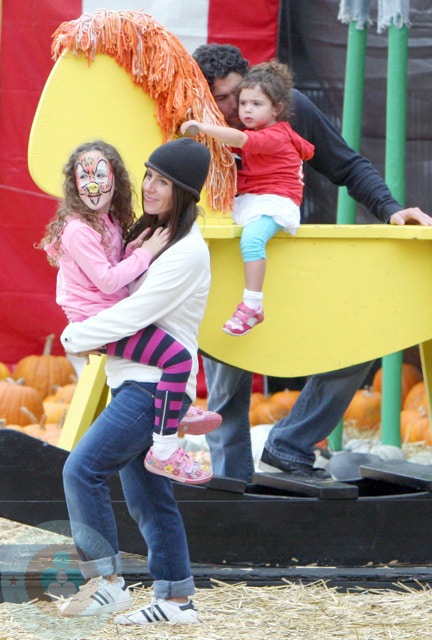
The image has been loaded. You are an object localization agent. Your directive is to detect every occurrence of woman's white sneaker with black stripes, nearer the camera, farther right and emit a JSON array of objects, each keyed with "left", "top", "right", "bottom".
[{"left": 114, "top": 598, "right": 198, "bottom": 625}]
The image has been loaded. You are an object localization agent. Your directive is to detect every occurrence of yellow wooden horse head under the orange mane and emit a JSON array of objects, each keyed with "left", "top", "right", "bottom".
[{"left": 28, "top": 54, "right": 162, "bottom": 204}]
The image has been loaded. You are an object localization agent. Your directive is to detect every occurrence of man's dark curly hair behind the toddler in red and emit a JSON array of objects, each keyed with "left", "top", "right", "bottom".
[{"left": 192, "top": 43, "right": 249, "bottom": 89}]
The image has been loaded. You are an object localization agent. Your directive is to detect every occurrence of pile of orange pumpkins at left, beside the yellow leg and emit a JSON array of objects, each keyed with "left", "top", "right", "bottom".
[{"left": 0, "top": 336, "right": 76, "bottom": 444}]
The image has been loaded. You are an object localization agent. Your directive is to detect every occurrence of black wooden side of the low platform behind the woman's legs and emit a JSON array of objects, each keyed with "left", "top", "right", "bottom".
[{"left": 0, "top": 429, "right": 432, "bottom": 569}]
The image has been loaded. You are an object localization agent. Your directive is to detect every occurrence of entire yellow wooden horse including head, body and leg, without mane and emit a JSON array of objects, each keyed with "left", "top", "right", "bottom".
[{"left": 28, "top": 54, "right": 432, "bottom": 449}]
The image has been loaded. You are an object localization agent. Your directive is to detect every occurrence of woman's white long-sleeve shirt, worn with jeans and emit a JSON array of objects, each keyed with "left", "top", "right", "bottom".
[{"left": 61, "top": 223, "right": 210, "bottom": 400}]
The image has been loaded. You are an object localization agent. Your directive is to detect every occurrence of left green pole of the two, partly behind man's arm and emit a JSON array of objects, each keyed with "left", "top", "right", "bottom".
[{"left": 328, "top": 21, "right": 367, "bottom": 451}]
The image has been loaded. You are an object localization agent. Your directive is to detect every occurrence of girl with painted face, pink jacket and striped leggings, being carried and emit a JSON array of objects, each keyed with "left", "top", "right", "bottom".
[{"left": 39, "top": 141, "right": 216, "bottom": 484}]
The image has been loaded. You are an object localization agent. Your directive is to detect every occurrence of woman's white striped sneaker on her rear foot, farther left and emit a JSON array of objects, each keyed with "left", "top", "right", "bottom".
[{"left": 59, "top": 576, "right": 132, "bottom": 616}]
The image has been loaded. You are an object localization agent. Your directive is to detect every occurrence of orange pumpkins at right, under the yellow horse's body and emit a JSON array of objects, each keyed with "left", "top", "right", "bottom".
[{"left": 249, "top": 363, "right": 432, "bottom": 446}]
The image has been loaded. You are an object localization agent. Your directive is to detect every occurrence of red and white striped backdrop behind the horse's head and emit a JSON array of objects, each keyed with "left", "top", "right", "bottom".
[{"left": 0, "top": 0, "right": 279, "bottom": 364}]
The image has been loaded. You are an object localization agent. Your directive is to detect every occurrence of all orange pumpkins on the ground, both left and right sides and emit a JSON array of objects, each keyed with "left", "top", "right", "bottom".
[{"left": 0, "top": 336, "right": 432, "bottom": 446}]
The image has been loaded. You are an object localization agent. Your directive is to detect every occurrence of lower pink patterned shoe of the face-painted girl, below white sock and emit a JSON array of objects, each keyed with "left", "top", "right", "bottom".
[{"left": 144, "top": 447, "right": 213, "bottom": 484}]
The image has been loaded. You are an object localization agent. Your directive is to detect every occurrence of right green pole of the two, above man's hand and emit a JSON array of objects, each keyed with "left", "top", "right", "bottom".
[{"left": 381, "top": 24, "right": 408, "bottom": 447}]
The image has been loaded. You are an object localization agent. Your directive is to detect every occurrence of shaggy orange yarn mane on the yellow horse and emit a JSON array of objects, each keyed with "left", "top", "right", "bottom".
[{"left": 51, "top": 9, "right": 235, "bottom": 212}]
